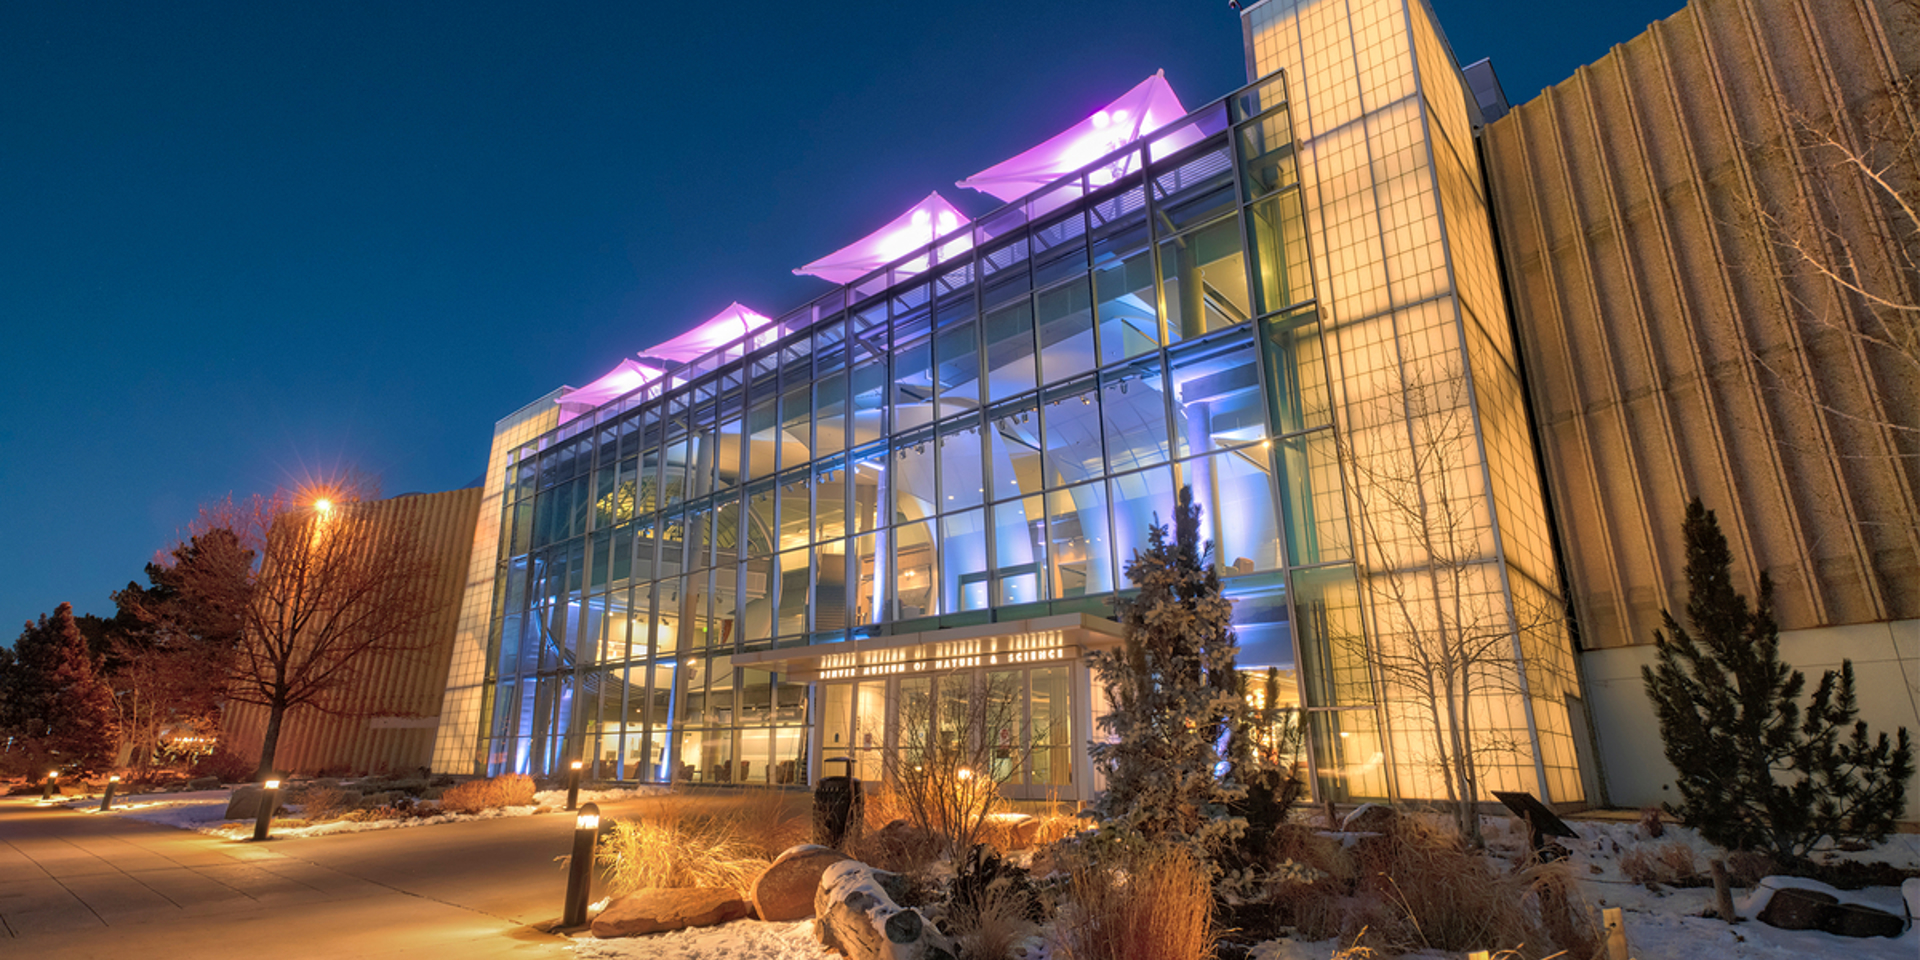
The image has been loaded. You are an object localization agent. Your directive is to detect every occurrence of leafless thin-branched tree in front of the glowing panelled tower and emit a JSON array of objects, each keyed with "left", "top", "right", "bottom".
[{"left": 1340, "top": 374, "right": 1565, "bottom": 843}]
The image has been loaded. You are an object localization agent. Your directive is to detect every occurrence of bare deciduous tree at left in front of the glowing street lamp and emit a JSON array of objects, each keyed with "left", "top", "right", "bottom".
[{"left": 161, "top": 484, "right": 432, "bottom": 776}]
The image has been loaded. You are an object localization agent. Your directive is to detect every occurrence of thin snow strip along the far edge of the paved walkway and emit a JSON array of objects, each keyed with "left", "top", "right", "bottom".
[{"left": 54, "top": 787, "right": 664, "bottom": 839}]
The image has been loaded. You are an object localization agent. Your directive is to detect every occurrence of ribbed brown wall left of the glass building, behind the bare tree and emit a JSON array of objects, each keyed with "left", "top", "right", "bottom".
[{"left": 221, "top": 490, "right": 480, "bottom": 774}]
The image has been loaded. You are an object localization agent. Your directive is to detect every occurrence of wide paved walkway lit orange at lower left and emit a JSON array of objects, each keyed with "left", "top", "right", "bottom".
[{"left": 0, "top": 799, "right": 637, "bottom": 960}]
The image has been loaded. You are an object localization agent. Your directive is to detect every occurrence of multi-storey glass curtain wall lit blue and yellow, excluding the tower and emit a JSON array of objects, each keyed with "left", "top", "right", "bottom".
[{"left": 472, "top": 74, "right": 1350, "bottom": 783}]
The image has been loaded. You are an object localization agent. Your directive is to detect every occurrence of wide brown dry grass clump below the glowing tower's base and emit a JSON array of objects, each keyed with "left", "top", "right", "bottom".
[{"left": 1271, "top": 816, "right": 1599, "bottom": 958}]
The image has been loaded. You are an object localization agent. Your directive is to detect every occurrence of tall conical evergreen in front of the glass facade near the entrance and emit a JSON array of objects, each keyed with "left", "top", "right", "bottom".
[{"left": 1091, "top": 488, "right": 1244, "bottom": 854}]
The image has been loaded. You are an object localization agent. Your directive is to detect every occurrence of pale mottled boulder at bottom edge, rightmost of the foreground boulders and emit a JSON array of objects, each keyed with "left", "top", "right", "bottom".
[{"left": 814, "top": 860, "right": 956, "bottom": 960}]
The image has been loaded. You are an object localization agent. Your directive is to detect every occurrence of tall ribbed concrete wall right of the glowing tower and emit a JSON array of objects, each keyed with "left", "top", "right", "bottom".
[{"left": 1484, "top": 0, "right": 1920, "bottom": 659}]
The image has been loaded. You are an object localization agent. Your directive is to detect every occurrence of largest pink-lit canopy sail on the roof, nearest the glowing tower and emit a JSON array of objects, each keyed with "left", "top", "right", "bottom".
[{"left": 960, "top": 71, "right": 1187, "bottom": 200}]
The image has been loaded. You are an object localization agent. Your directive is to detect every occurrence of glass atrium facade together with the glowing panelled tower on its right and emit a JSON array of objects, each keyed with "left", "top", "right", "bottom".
[{"left": 476, "top": 0, "right": 1582, "bottom": 803}]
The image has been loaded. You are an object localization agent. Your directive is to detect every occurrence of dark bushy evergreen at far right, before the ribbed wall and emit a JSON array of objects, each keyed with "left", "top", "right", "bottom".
[{"left": 1642, "top": 497, "right": 1914, "bottom": 864}]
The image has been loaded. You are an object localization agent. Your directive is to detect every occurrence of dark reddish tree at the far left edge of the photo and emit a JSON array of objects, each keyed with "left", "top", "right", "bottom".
[{"left": 6, "top": 603, "right": 119, "bottom": 774}]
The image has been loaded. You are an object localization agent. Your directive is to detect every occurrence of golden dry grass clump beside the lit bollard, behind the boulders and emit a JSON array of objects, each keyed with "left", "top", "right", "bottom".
[{"left": 599, "top": 789, "right": 812, "bottom": 897}]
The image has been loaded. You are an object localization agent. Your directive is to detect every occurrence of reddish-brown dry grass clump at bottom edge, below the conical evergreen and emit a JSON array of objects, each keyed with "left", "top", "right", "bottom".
[{"left": 1052, "top": 847, "right": 1219, "bottom": 960}]
